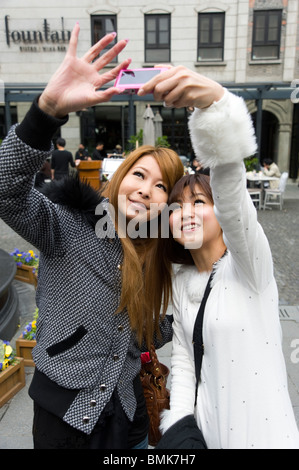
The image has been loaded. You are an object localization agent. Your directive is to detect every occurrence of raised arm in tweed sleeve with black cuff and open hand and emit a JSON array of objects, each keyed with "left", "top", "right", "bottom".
[{"left": 0, "top": 24, "right": 130, "bottom": 251}]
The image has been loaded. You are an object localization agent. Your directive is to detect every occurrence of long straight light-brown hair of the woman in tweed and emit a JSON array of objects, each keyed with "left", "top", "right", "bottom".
[{"left": 102, "top": 145, "right": 184, "bottom": 346}]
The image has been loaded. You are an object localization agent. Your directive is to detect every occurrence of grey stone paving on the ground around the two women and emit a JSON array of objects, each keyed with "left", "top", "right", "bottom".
[{"left": 0, "top": 183, "right": 299, "bottom": 449}]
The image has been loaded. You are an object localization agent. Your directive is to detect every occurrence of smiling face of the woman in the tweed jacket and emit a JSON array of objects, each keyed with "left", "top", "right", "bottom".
[{"left": 118, "top": 155, "right": 168, "bottom": 222}]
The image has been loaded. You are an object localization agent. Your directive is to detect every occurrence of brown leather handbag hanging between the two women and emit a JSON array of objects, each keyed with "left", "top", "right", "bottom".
[{"left": 140, "top": 345, "right": 170, "bottom": 447}]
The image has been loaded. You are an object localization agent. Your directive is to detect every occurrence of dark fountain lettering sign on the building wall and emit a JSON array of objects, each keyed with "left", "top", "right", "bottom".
[{"left": 5, "top": 15, "right": 71, "bottom": 52}]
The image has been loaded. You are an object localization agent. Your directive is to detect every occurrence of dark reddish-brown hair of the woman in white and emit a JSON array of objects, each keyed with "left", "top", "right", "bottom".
[{"left": 165, "top": 173, "right": 214, "bottom": 265}]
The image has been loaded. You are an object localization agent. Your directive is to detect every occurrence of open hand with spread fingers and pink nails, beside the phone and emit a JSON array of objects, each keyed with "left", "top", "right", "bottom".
[{"left": 38, "top": 24, "right": 131, "bottom": 118}]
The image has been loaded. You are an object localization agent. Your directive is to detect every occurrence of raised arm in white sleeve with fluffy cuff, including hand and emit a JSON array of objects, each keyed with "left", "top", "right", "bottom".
[{"left": 141, "top": 66, "right": 273, "bottom": 291}]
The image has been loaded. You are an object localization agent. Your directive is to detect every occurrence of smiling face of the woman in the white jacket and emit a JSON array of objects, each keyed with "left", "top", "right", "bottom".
[{"left": 169, "top": 184, "right": 221, "bottom": 250}]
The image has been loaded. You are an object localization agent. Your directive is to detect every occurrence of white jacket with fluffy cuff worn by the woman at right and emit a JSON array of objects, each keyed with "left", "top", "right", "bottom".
[{"left": 162, "top": 91, "right": 299, "bottom": 449}]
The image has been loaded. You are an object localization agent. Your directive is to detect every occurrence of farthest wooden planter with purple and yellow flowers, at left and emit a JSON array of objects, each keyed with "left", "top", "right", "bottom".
[{"left": 10, "top": 249, "right": 39, "bottom": 287}]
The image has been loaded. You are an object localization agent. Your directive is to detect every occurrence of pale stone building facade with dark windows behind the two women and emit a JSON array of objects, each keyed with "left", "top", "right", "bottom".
[{"left": 0, "top": 0, "right": 299, "bottom": 178}]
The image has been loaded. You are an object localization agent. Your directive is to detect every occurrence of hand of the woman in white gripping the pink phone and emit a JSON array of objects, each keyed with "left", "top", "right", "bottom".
[{"left": 138, "top": 65, "right": 224, "bottom": 108}]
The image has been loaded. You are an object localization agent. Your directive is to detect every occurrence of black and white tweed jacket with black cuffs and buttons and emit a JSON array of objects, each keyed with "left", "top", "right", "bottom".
[{"left": 0, "top": 103, "right": 172, "bottom": 434}]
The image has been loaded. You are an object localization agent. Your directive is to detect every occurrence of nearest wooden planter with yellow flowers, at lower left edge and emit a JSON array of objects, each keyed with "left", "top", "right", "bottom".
[{"left": 0, "top": 340, "right": 25, "bottom": 408}]
